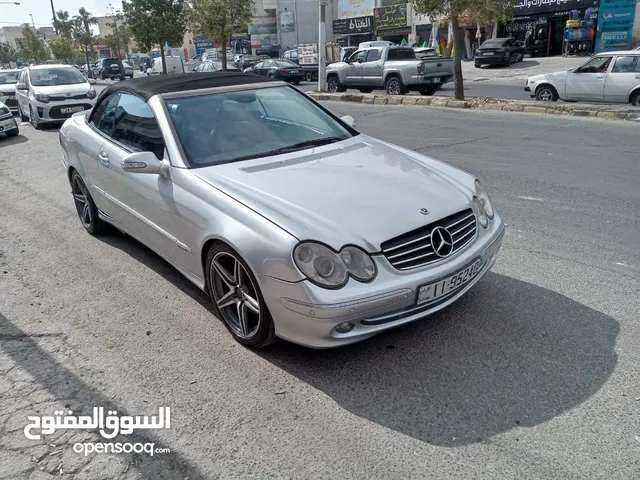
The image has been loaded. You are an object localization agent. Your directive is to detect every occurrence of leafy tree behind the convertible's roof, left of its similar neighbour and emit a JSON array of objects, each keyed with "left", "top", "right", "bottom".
[{"left": 122, "top": 0, "right": 186, "bottom": 73}]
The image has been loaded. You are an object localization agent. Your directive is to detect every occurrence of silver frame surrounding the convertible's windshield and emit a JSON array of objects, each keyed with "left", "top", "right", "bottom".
[{"left": 158, "top": 80, "right": 360, "bottom": 170}]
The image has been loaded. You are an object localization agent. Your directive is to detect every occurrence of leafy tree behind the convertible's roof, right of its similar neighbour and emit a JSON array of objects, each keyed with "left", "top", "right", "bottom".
[{"left": 185, "top": 0, "right": 255, "bottom": 70}]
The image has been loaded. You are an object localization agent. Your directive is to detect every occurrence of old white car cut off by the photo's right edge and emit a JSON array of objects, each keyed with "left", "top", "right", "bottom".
[{"left": 524, "top": 50, "right": 640, "bottom": 107}]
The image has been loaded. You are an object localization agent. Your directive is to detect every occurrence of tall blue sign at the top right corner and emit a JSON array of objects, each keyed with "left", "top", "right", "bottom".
[{"left": 596, "top": 0, "right": 638, "bottom": 53}]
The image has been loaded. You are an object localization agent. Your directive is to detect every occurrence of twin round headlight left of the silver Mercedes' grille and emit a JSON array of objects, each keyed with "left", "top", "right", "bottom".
[{"left": 293, "top": 242, "right": 377, "bottom": 288}]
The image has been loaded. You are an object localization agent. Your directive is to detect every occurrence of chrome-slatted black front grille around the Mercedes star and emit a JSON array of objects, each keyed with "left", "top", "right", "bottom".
[{"left": 381, "top": 208, "right": 478, "bottom": 270}]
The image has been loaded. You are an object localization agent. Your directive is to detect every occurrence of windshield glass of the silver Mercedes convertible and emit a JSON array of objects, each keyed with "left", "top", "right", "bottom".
[{"left": 166, "top": 86, "right": 353, "bottom": 168}]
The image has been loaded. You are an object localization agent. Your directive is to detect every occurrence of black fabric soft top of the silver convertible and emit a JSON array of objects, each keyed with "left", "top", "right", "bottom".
[{"left": 96, "top": 72, "right": 273, "bottom": 105}]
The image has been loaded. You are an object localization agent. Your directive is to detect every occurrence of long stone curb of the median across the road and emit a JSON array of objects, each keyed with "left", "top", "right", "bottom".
[{"left": 306, "top": 92, "right": 640, "bottom": 122}]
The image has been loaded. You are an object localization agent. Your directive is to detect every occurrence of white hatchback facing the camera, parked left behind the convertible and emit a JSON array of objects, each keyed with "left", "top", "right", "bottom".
[{"left": 16, "top": 65, "right": 96, "bottom": 129}]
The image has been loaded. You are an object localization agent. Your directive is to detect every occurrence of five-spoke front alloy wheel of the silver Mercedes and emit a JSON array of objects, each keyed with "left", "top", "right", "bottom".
[{"left": 209, "top": 252, "right": 262, "bottom": 339}]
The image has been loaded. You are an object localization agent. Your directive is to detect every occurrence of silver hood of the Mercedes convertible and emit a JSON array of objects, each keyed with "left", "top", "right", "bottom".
[{"left": 192, "top": 134, "right": 474, "bottom": 252}]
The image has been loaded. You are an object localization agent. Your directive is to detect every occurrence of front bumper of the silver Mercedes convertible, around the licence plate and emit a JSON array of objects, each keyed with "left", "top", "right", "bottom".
[{"left": 259, "top": 215, "right": 505, "bottom": 348}]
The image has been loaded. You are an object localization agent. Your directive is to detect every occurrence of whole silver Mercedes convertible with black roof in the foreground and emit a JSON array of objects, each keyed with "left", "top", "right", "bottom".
[{"left": 60, "top": 72, "right": 504, "bottom": 348}]
